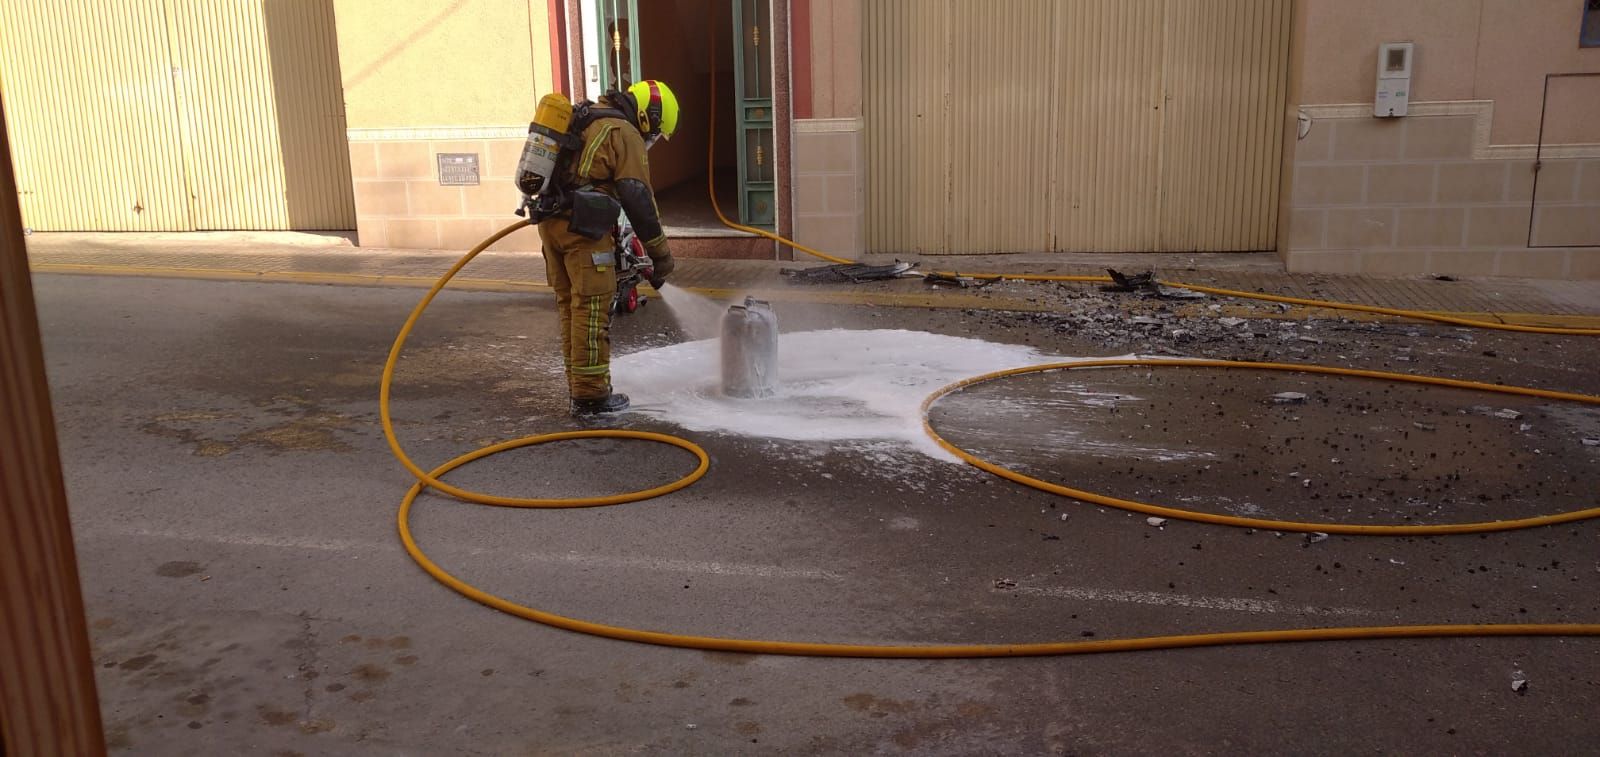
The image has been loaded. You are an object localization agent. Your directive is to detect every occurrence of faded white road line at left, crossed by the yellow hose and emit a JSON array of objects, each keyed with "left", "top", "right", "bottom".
[{"left": 78, "top": 528, "right": 845, "bottom": 581}]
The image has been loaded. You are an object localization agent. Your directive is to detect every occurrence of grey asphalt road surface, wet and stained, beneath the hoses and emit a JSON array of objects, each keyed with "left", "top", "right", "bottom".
[{"left": 35, "top": 274, "right": 1600, "bottom": 755}]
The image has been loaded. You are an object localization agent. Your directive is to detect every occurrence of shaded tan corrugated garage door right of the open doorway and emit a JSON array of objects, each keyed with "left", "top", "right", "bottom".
[{"left": 864, "top": 0, "right": 1288, "bottom": 253}]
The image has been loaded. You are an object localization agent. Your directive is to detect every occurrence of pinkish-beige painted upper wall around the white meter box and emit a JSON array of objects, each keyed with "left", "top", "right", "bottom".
[{"left": 1296, "top": 0, "right": 1600, "bottom": 144}]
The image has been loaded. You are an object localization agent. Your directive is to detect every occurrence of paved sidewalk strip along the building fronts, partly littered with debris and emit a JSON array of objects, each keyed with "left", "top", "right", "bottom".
[{"left": 29, "top": 232, "right": 1600, "bottom": 326}]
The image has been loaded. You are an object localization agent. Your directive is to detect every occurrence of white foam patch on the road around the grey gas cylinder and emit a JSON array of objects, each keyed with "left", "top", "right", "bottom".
[{"left": 611, "top": 328, "right": 1100, "bottom": 461}]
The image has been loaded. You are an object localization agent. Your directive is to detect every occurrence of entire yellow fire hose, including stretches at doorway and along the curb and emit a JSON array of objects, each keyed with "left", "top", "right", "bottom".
[{"left": 379, "top": 26, "right": 1600, "bottom": 658}]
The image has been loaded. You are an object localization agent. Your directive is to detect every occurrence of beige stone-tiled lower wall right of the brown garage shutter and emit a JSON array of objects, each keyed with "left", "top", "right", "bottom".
[{"left": 1283, "top": 112, "right": 1600, "bottom": 278}]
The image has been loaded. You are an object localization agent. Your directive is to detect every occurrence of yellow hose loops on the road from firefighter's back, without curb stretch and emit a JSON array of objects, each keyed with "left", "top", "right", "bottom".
[{"left": 379, "top": 222, "right": 1600, "bottom": 658}]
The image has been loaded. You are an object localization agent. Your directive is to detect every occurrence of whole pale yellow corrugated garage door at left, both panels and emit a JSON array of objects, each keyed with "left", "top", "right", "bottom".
[{"left": 0, "top": 0, "right": 355, "bottom": 230}]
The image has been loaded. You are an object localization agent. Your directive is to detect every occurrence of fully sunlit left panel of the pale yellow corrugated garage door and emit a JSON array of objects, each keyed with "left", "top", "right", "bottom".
[{"left": 0, "top": 0, "right": 194, "bottom": 232}]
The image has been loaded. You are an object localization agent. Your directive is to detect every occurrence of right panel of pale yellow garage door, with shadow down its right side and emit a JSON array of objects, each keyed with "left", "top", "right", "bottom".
[{"left": 168, "top": 0, "right": 355, "bottom": 229}]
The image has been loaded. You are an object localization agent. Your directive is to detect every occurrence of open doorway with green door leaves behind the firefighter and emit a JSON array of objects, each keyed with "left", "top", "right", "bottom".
[{"left": 584, "top": 0, "right": 773, "bottom": 237}]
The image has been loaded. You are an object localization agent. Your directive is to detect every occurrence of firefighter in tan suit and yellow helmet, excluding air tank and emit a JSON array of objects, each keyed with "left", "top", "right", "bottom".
[{"left": 539, "top": 80, "right": 678, "bottom": 415}]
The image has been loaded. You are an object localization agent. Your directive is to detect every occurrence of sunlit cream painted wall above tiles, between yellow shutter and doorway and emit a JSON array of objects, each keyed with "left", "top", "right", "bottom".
[{"left": 334, "top": 0, "right": 558, "bottom": 128}]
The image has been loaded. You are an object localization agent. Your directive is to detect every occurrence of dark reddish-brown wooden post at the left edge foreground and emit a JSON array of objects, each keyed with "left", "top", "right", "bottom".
[{"left": 0, "top": 94, "right": 106, "bottom": 755}]
